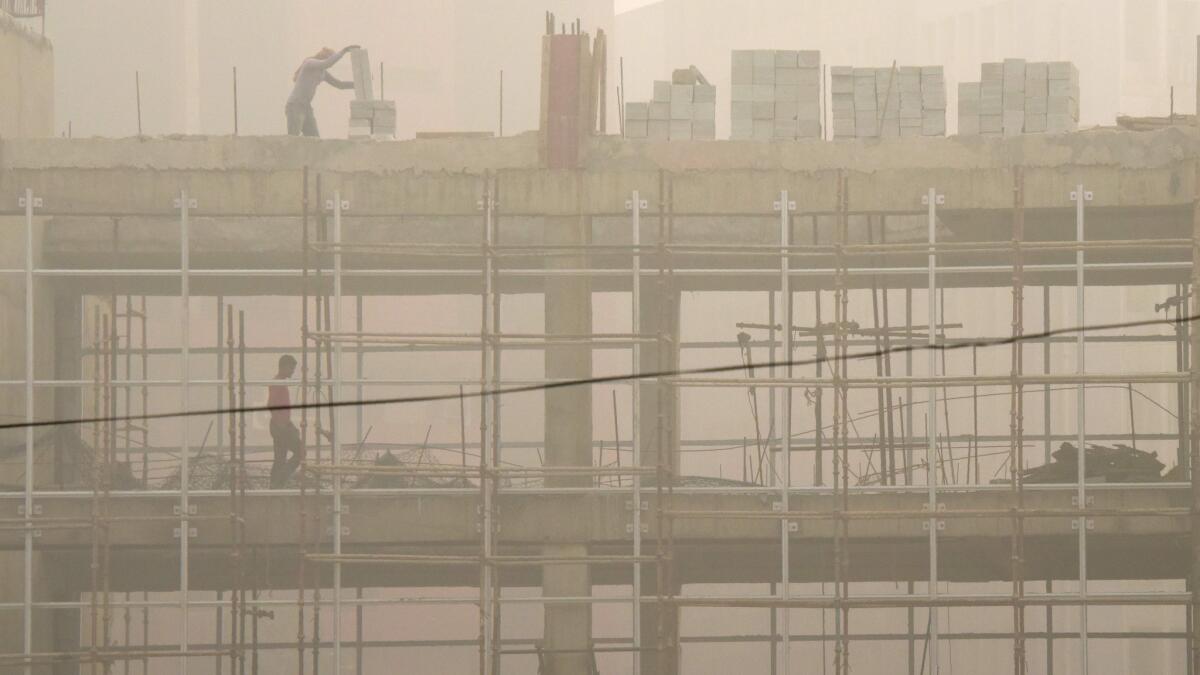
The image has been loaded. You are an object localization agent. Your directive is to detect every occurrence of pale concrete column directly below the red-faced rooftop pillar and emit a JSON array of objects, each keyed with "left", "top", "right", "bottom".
[{"left": 542, "top": 176, "right": 594, "bottom": 675}]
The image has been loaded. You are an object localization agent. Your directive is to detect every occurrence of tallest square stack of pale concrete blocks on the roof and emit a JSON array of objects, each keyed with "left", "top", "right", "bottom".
[{"left": 730, "top": 49, "right": 821, "bottom": 141}]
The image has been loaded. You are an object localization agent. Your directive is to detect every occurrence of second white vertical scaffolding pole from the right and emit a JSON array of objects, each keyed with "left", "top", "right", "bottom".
[{"left": 923, "top": 187, "right": 943, "bottom": 675}]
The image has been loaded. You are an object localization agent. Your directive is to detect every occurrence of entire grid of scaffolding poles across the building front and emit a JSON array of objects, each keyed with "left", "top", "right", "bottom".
[{"left": 0, "top": 167, "right": 1200, "bottom": 675}]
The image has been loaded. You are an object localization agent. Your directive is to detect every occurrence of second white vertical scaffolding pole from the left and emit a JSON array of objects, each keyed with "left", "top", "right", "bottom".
[{"left": 175, "top": 190, "right": 197, "bottom": 675}]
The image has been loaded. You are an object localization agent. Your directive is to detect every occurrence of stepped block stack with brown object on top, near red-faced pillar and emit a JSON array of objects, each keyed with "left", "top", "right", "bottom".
[{"left": 625, "top": 66, "right": 716, "bottom": 141}]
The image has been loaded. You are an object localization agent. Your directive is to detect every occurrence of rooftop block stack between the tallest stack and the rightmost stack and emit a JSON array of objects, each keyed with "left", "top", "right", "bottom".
[{"left": 829, "top": 66, "right": 946, "bottom": 138}]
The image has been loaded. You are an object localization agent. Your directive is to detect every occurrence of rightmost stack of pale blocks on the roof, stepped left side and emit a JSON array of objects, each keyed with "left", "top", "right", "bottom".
[{"left": 959, "top": 59, "right": 1079, "bottom": 136}]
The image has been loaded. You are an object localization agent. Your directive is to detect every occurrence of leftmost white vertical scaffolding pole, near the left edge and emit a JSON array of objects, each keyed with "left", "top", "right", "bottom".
[{"left": 22, "top": 187, "right": 37, "bottom": 675}]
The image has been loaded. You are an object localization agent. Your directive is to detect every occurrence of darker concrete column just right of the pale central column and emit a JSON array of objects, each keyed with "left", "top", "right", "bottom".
[{"left": 638, "top": 265, "right": 680, "bottom": 675}]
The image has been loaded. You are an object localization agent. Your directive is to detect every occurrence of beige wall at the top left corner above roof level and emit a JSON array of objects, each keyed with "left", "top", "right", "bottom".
[{"left": 0, "top": 14, "right": 54, "bottom": 138}]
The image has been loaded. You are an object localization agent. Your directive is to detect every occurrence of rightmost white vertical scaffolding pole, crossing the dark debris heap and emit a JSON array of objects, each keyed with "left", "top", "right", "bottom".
[{"left": 1072, "top": 184, "right": 1092, "bottom": 675}]
